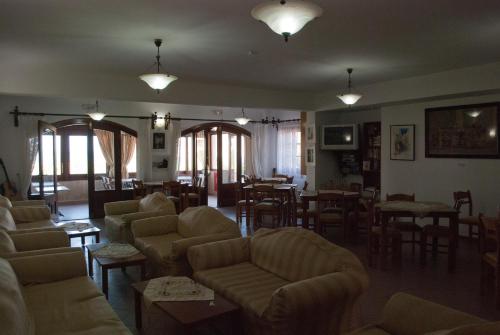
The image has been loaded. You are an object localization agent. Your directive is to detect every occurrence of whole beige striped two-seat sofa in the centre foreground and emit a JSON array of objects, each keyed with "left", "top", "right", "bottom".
[{"left": 188, "top": 228, "right": 369, "bottom": 335}]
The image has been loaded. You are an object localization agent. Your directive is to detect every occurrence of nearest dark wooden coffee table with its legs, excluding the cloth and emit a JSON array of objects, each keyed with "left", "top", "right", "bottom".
[{"left": 132, "top": 281, "right": 240, "bottom": 334}]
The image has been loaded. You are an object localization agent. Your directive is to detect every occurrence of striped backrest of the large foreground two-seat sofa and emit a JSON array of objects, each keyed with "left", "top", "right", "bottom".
[{"left": 250, "top": 228, "right": 366, "bottom": 282}]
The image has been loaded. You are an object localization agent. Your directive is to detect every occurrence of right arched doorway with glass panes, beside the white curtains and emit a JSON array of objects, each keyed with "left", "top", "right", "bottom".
[{"left": 178, "top": 122, "right": 252, "bottom": 207}]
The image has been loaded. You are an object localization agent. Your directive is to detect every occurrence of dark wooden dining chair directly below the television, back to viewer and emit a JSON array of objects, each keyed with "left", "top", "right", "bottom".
[{"left": 315, "top": 191, "right": 348, "bottom": 239}]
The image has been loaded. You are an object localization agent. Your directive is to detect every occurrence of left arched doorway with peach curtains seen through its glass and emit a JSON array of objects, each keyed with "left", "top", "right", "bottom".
[{"left": 32, "top": 118, "right": 137, "bottom": 219}]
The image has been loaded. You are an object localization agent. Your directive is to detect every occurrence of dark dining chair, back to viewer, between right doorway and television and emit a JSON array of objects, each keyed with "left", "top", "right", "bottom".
[{"left": 251, "top": 184, "right": 282, "bottom": 230}]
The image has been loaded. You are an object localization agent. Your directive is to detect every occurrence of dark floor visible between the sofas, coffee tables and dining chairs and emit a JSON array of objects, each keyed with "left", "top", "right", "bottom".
[{"left": 79, "top": 208, "right": 500, "bottom": 333}]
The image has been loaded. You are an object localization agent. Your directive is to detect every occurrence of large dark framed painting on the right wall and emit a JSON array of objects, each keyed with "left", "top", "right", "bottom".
[{"left": 425, "top": 102, "right": 500, "bottom": 158}]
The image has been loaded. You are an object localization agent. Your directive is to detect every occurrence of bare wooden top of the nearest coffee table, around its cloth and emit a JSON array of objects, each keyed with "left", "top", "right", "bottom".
[{"left": 132, "top": 281, "right": 239, "bottom": 326}]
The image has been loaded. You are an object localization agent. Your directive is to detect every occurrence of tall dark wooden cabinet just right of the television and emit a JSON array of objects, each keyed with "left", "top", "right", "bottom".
[{"left": 361, "top": 122, "right": 382, "bottom": 190}]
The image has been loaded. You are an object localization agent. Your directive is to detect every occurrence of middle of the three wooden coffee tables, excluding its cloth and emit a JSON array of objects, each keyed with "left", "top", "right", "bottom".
[{"left": 85, "top": 243, "right": 146, "bottom": 299}]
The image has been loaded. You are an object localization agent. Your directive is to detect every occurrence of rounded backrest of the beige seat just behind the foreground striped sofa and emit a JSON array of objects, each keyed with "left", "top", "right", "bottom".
[{"left": 177, "top": 206, "right": 241, "bottom": 237}]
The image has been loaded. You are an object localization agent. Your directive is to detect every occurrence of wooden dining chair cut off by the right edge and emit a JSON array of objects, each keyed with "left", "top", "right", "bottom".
[{"left": 478, "top": 214, "right": 500, "bottom": 309}]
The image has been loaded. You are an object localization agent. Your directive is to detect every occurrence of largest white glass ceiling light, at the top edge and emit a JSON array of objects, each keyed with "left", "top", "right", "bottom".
[{"left": 252, "top": 0, "right": 323, "bottom": 42}]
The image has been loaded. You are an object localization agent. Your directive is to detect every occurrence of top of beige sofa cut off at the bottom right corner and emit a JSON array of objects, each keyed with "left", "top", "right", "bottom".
[{"left": 349, "top": 293, "right": 500, "bottom": 335}]
